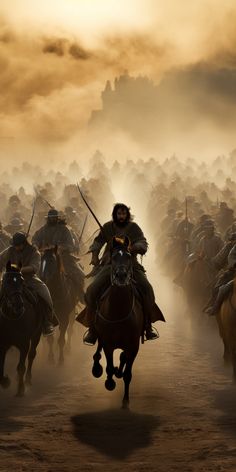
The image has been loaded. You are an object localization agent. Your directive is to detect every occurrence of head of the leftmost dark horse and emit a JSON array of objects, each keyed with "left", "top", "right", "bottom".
[{"left": 0, "top": 261, "right": 25, "bottom": 320}]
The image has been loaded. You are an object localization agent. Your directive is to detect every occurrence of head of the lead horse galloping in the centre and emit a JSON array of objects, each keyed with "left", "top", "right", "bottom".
[{"left": 111, "top": 236, "right": 133, "bottom": 286}]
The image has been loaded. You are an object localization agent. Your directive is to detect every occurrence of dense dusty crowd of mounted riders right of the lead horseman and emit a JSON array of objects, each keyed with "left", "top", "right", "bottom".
[{"left": 148, "top": 152, "right": 236, "bottom": 378}]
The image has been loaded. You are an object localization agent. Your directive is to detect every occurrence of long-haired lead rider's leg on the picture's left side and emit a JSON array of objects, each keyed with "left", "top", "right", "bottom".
[{"left": 84, "top": 265, "right": 111, "bottom": 345}]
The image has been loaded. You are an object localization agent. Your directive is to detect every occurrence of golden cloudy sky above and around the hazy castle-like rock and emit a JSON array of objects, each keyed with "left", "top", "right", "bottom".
[{"left": 0, "top": 0, "right": 236, "bottom": 160}]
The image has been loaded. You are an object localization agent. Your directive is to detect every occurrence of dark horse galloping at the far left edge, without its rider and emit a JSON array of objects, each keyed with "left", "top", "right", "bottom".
[{"left": 0, "top": 262, "right": 43, "bottom": 396}]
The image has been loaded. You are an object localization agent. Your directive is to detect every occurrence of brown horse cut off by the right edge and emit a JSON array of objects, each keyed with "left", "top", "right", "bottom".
[{"left": 216, "top": 278, "right": 236, "bottom": 381}]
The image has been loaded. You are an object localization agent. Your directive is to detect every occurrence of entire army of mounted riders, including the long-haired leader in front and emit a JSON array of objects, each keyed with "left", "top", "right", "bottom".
[{"left": 0, "top": 152, "right": 236, "bottom": 404}]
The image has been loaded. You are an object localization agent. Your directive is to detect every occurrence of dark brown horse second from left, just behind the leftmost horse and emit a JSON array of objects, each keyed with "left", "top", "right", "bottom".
[{"left": 40, "top": 247, "right": 81, "bottom": 365}]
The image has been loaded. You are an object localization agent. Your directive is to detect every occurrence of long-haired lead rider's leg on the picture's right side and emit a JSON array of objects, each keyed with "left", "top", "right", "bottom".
[{"left": 134, "top": 269, "right": 159, "bottom": 340}]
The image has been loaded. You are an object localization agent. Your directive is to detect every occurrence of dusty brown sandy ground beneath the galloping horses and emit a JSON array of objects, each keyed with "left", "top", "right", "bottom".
[{"left": 0, "top": 274, "right": 236, "bottom": 472}]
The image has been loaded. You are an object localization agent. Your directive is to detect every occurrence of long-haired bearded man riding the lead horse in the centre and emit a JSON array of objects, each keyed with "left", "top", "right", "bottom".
[{"left": 78, "top": 203, "right": 165, "bottom": 344}]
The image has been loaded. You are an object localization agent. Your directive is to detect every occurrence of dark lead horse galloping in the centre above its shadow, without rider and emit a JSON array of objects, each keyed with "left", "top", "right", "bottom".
[{"left": 92, "top": 238, "right": 144, "bottom": 408}]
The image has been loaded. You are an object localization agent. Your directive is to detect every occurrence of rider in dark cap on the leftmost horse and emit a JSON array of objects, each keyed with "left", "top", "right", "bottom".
[{"left": 0, "top": 232, "right": 56, "bottom": 336}]
